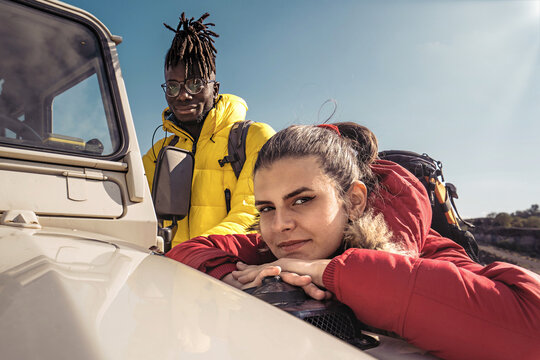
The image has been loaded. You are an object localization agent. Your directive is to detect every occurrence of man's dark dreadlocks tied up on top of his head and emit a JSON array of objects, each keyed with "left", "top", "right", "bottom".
[{"left": 163, "top": 13, "right": 219, "bottom": 79}]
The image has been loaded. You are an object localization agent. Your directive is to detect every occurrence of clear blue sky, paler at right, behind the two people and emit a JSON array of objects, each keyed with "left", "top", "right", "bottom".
[{"left": 66, "top": 0, "right": 540, "bottom": 218}]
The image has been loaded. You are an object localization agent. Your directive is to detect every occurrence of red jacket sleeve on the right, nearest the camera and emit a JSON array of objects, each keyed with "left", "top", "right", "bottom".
[{"left": 323, "top": 234, "right": 540, "bottom": 359}]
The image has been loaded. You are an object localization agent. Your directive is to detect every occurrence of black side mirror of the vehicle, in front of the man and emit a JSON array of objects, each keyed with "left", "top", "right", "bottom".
[{"left": 152, "top": 146, "right": 194, "bottom": 251}]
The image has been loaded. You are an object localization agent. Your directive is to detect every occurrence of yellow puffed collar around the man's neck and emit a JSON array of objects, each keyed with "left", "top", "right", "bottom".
[{"left": 161, "top": 94, "right": 248, "bottom": 140}]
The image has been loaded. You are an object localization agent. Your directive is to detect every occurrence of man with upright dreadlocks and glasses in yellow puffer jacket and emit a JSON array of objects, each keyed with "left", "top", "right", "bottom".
[{"left": 143, "top": 13, "right": 274, "bottom": 246}]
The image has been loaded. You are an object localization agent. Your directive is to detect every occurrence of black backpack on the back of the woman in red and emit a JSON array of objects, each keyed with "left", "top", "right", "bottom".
[{"left": 379, "top": 150, "right": 479, "bottom": 262}]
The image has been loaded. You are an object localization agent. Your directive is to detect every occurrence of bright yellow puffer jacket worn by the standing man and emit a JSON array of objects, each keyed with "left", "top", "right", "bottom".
[{"left": 143, "top": 94, "right": 275, "bottom": 246}]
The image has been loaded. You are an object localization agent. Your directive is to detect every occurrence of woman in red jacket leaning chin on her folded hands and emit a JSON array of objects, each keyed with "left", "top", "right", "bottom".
[{"left": 167, "top": 123, "right": 540, "bottom": 359}]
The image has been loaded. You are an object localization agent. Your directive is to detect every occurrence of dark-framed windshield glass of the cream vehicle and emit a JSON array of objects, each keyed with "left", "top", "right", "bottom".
[{"left": 0, "top": 0, "right": 122, "bottom": 156}]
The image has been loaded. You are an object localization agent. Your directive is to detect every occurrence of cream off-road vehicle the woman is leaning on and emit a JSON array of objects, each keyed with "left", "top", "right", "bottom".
[{"left": 0, "top": 0, "right": 432, "bottom": 360}]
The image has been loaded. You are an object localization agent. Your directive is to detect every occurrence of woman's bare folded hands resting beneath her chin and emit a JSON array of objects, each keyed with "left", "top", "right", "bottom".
[{"left": 230, "top": 258, "right": 332, "bottom": 300}]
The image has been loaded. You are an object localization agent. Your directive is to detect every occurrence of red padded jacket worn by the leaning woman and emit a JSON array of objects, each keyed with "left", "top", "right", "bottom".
[{"left": 167, "top": 160, "right": 540, "bottom": 359}]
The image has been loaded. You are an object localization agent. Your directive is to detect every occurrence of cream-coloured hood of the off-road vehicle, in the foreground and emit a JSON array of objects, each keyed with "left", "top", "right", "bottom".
[{"left": 0, "top": 226, "right": 376, "bottom": 359}]
